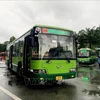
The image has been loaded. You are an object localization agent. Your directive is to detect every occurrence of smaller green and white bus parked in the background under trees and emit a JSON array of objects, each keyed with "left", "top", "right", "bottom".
[{"left": 78, "top": 48, "right": 97, "bottom": 64}]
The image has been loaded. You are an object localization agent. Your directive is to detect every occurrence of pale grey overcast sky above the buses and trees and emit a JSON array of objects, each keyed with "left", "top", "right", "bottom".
[{"left": 0, "top": 0, "right": 100, "bottom": 43}]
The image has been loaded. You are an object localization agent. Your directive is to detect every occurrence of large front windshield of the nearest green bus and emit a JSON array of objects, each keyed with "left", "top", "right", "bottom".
[{"left": 39, "top": 34, "right": 75, "bottom": 59}]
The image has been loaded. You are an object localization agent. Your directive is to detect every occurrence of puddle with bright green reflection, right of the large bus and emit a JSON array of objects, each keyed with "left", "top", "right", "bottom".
[{"left": 77, "top": 66, "right": 100, "bottom": 84}]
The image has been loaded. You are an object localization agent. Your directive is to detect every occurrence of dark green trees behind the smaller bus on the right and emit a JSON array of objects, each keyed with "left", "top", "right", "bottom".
[{"left": 78, "top": 26, "right": 100, "bottom": 49}]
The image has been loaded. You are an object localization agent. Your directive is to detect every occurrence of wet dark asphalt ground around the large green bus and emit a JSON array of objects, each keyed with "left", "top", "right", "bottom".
[{"left": 0, "top": 62, "right": 100, "bottom": 100}]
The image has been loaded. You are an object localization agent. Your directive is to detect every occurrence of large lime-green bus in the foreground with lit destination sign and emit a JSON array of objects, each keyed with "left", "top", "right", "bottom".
[{"left": 6, "top": 25, "right": 76, "bottom": 81}]
